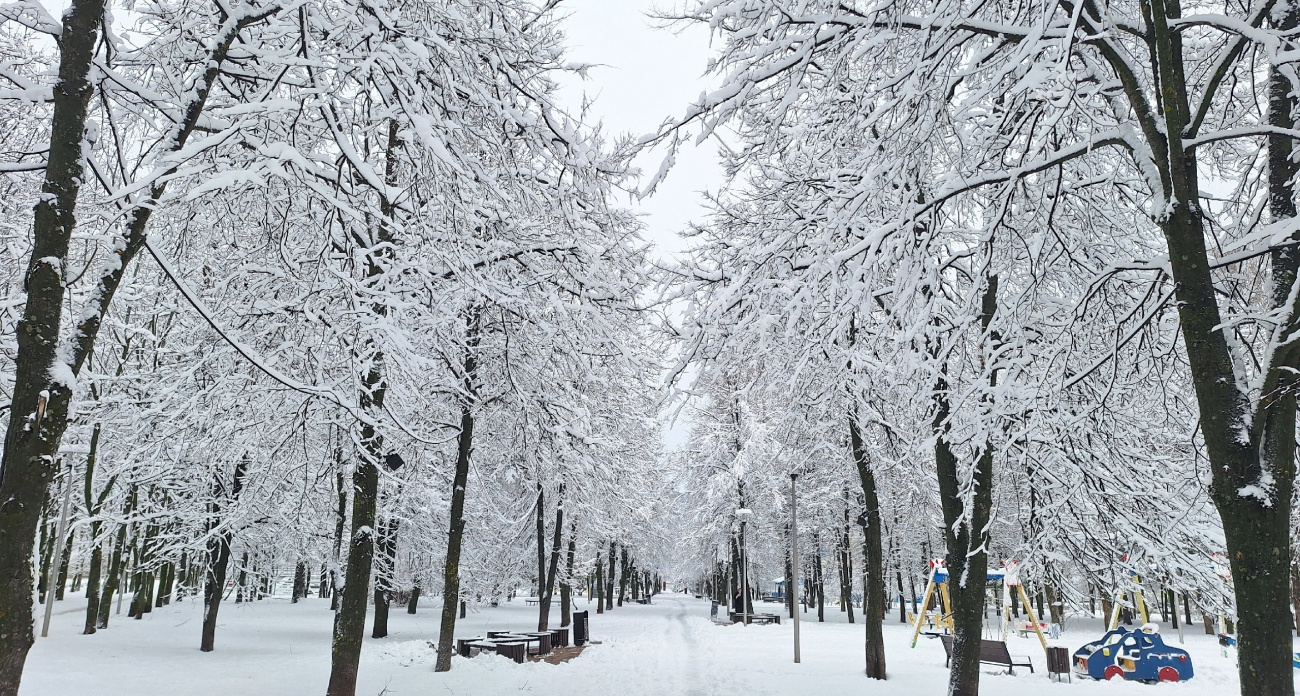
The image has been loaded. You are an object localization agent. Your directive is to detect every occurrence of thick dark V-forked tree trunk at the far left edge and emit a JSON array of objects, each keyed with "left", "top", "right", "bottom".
[{"left": 0, "top": 8, "right": 274, "bottom": 696}]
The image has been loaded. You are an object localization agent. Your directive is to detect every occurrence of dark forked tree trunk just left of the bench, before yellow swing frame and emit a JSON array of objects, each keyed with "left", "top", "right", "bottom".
[{"left": 932, "top": 276, "right": 997, "bottom": 696}]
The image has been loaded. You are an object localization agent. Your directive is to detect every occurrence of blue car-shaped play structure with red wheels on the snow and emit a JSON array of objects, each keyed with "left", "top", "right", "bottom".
[{"left": 1074, "top": 624, "right": 1192, "bottom": 682}]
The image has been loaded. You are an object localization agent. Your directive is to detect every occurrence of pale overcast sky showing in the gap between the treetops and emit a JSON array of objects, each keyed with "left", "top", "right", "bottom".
[{"left": 560, "top": 0, "right": 722, "bottom": 261}]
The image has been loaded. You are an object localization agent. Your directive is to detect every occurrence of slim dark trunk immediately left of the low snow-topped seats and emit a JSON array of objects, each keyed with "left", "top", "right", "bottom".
[{"left": 434, "top": 308, "right": 481, "bottom": 671}]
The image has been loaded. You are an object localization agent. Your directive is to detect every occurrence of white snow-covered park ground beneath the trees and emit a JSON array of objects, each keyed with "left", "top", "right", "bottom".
[{"left": 22, "top": 595, "right": 1289, "bottom": 696}]
